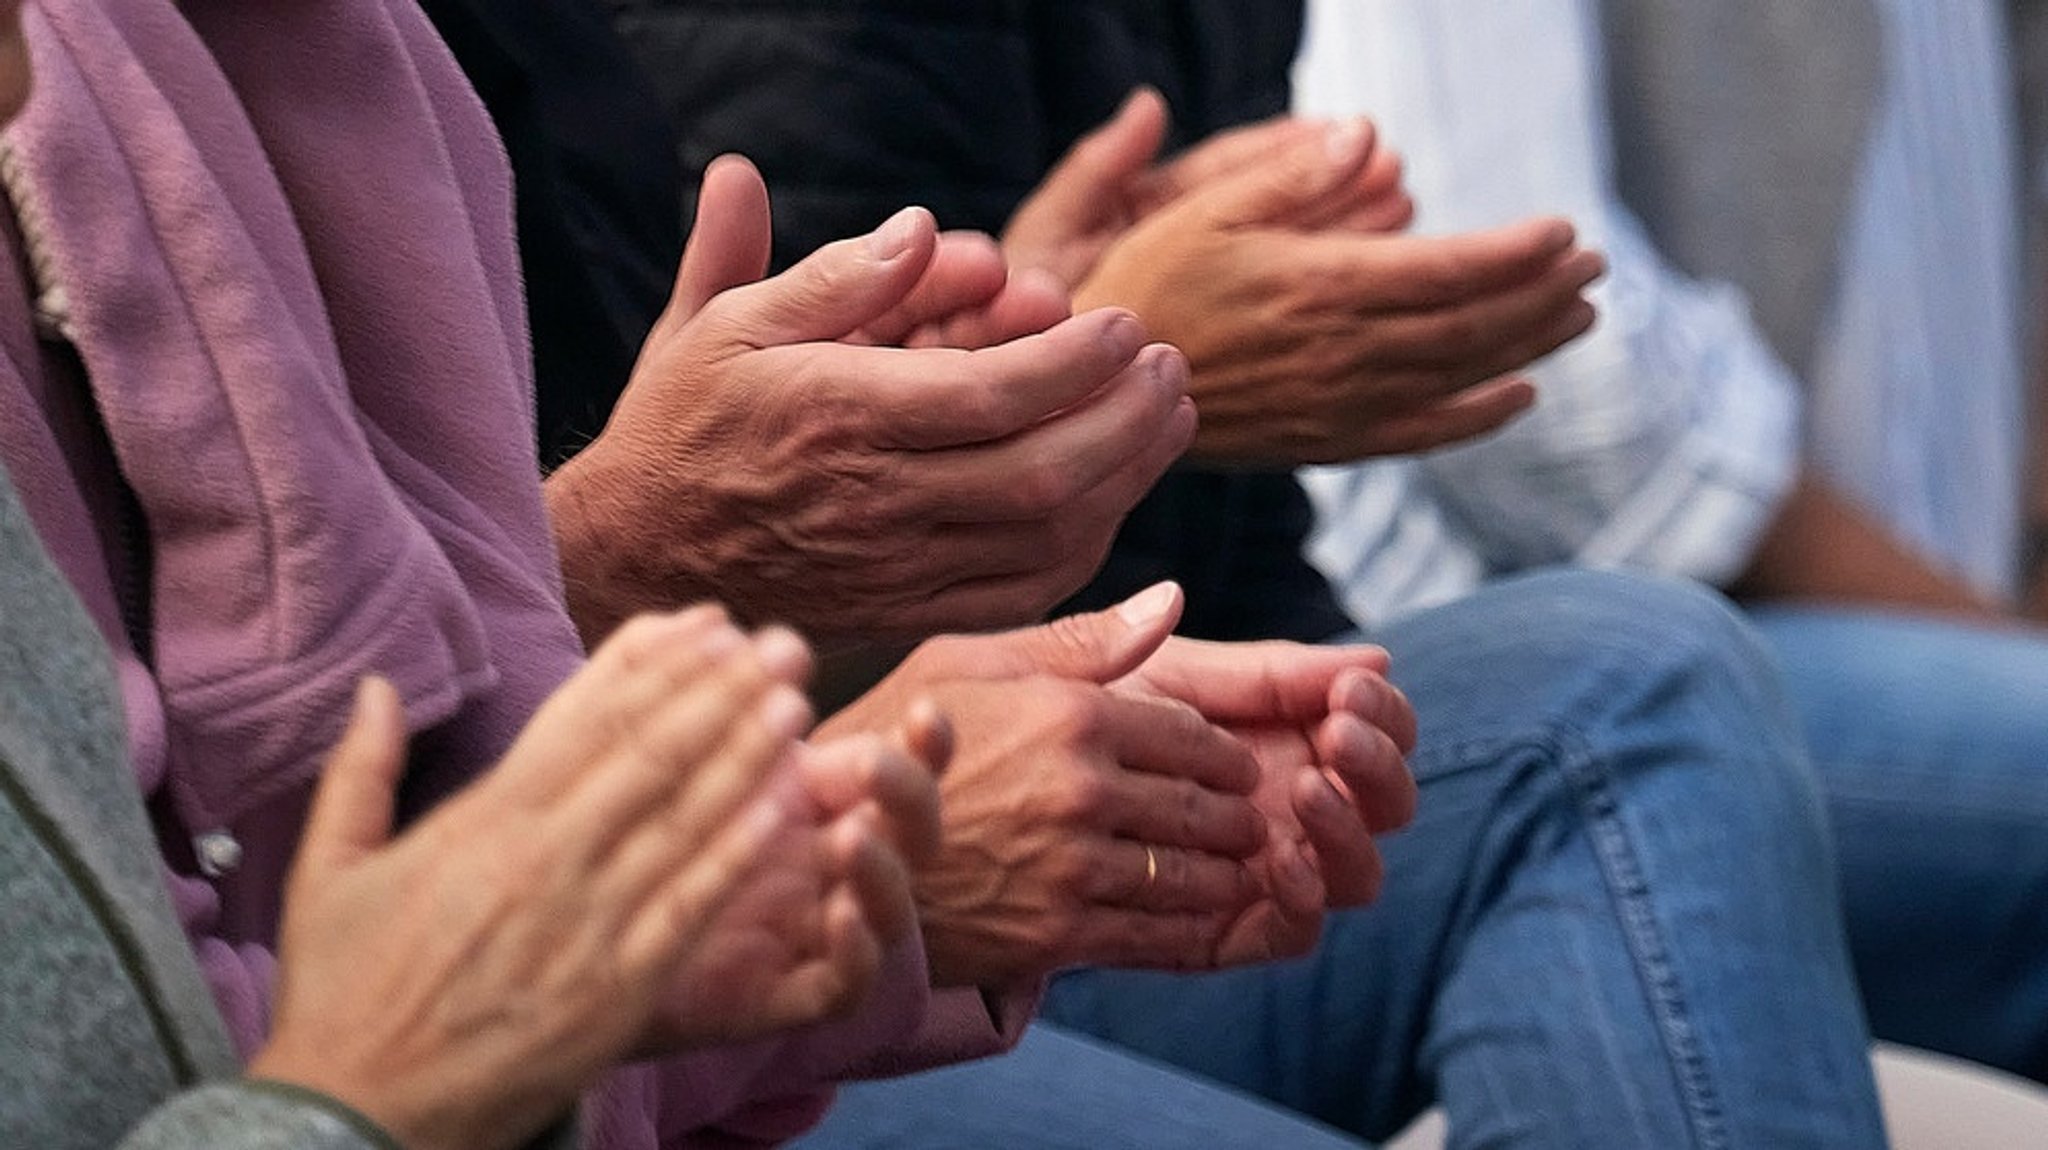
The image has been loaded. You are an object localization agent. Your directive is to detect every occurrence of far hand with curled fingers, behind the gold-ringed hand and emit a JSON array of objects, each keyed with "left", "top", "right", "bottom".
[{"left": 1114, "top": 626, "right": 1415, "bottom": 958}]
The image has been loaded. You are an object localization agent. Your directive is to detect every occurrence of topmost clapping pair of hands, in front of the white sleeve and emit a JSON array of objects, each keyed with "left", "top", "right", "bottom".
[{"left": 1006, "top": 85, "right": 1604, "bottom": 467}]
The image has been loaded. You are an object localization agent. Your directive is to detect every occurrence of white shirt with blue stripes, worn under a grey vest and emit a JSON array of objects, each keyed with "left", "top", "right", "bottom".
[{"left": 1296, "top": 0, "right": 2021, "bottom": 620}]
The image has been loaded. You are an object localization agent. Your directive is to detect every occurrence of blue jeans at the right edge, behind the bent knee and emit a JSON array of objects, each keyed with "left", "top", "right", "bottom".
[{"left": 1751, "top": 608, "right": 2048, "bottom": 1080}]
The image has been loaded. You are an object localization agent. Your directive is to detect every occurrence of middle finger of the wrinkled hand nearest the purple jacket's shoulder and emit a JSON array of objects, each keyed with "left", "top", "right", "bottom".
[{"left": 915, "top": 344, "right": 1188, "bottom": 522}]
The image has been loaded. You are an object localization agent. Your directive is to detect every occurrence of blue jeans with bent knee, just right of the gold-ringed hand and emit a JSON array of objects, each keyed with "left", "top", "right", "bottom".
[{"left": 805, "top": 573, "right": 1882, "bottom": 1148}]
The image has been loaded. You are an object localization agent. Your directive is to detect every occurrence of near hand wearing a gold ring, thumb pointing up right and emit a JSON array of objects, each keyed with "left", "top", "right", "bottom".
[{"left": 825, "top": 583, "right": 1376, "bottom": 986}]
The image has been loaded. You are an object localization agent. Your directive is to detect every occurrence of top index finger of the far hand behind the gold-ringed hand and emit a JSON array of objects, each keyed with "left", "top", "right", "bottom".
[{"left": 1130, "top": 638, "right": 1389, "bottom": 726}]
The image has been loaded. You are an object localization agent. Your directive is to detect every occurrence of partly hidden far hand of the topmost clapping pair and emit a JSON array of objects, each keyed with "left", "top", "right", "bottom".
[{"left": 1004, "top": 88, "right": 1415, "bottom": 289}]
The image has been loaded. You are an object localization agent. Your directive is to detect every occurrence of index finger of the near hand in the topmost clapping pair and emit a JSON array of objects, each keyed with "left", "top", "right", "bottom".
[{"left": 1296, "top": 219, "right": 1577, "bottom": 311}]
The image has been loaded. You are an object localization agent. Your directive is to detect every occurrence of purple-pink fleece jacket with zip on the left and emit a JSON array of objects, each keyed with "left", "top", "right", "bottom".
[{"left": 0, "top": 0, "right": 1024, "bottom": 1150}]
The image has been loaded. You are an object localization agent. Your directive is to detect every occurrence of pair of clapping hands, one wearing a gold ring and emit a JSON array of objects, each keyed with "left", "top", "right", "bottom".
[{"left": 825, "top": 585, "right": 1413, "bottom": 986}]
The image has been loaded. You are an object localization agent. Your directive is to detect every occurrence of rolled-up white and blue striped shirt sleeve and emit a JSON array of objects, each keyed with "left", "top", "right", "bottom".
[{"left": 1296, "top": 0, "right": 1798, "bottom": 583}]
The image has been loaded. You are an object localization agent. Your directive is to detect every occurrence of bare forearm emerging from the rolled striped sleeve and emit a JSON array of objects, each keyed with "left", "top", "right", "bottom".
[{"left": 1729, "top": 475, "right": 2005, "bottom": 620}]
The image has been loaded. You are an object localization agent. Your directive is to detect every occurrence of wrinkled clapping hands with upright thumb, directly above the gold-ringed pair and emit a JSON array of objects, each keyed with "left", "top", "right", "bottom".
[{"left": 549, "top": 162, "right": 1194, "bottom": 638}]
